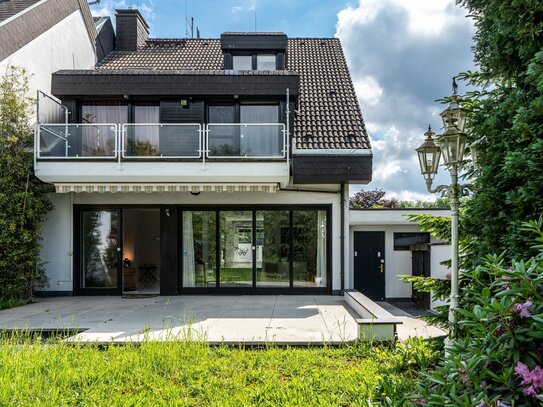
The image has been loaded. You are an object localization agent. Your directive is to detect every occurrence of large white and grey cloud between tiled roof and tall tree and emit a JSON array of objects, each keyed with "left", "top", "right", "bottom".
[{"left": 336, "top": 0, "right": 474, "bottom": 200}]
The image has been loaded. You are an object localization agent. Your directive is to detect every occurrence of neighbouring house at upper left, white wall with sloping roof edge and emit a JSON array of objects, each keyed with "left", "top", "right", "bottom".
[{"left": 0, "top": 0, "right": 97, "bottom": 102}]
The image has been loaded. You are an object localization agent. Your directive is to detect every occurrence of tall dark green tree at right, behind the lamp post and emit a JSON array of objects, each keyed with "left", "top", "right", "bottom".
[{"left": 458, "top": 0, "right": 543, "bottom": 257}]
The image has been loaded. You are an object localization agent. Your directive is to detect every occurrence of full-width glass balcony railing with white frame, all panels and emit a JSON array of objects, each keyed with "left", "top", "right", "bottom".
[{"left": 35, "top": 123, "right": 288, "bottom": 161}]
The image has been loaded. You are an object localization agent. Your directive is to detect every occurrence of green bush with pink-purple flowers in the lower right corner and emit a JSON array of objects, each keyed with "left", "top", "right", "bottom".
[{"left": 413, "top": 218, "right": 543, "bottom": 407}]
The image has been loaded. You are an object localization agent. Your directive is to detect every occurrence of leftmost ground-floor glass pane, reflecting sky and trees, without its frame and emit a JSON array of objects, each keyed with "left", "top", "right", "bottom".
[{"left": 80, "top": 211, "right": 120, "bottom": 288}]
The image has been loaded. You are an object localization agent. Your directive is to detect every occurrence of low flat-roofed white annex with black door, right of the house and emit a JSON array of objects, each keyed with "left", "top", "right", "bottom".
[{"left": 348, "top": 208, "right": 451, "bottom": 308}]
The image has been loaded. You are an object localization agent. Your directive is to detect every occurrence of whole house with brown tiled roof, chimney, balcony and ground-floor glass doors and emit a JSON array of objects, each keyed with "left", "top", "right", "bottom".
[{"left": 36, "top": 10, "right": 372, "bottom": 295}]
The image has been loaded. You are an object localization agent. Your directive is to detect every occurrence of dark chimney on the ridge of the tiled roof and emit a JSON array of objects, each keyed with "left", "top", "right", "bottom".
[{"left": 115, "top": 9, "right": 149, "bottom": 51}]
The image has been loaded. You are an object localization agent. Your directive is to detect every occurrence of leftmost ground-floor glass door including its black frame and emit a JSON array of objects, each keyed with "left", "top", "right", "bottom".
[{"left": 74, "top": 209, "right": 122, "bottom": 295}]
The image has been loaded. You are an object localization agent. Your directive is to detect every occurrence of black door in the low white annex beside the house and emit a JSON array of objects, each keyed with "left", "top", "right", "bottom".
[{"left": 354, "top": 232, "right": 385, "bottom": 301}]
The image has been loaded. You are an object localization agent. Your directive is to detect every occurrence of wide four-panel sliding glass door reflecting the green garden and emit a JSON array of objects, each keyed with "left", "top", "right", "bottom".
[{"left": 179, "top": 207, "right": 329, "bottom": 293}]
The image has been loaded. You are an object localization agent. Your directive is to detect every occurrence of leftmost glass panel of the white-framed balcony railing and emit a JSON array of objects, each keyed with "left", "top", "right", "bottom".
[{"left": 36, "top": 124, "right": 118, "bottom": 159}]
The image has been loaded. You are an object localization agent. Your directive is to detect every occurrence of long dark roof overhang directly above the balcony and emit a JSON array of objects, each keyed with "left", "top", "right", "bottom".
[{"left": 51, "top": 70, "right": 300, "bottom": 98}]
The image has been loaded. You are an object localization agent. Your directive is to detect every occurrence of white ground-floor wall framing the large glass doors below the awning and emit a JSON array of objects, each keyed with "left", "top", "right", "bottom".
[{"left": 40, "top": 185, "right": 348, "bottom": 293}]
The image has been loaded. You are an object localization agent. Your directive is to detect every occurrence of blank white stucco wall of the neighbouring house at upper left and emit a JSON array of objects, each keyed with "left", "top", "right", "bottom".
[{"left": 0, "top": 10, "right": 96, "bottom": 97}]
